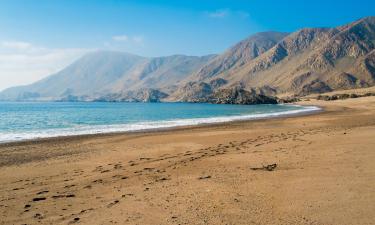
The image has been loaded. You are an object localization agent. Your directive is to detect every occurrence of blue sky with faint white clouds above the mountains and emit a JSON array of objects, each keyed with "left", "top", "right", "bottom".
[{"left": 0, "top": 0, "right": 375, "bottom": 90}]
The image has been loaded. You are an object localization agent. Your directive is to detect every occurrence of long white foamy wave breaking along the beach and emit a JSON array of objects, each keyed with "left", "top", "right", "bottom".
[{"left": 0, "top": 105, "right": 321, "bottom": 143}]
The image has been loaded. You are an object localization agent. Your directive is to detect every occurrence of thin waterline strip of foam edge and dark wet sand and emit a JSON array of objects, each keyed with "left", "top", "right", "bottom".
[{"left": 0, "top": 103, "right": 325, "bottom": 147}]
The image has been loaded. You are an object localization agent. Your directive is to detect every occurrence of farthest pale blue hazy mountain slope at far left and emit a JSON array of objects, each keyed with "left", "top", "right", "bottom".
[{"left": 1, "top": 51, "right": 146, "bottom": 100}]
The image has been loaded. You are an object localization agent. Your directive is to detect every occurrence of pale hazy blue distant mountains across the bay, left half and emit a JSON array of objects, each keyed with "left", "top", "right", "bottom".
[{"left": 0, "top": 51, "right": 215, "bottom": 101}]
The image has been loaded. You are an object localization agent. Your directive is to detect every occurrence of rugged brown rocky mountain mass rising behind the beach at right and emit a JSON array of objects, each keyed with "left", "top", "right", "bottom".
[{"left": 171, "top": 17, "right": 375, "bottom": 101}]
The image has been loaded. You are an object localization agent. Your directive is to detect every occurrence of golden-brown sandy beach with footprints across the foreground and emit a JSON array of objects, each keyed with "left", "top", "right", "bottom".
[{"left": 0, "top": 97, "right": 375, "bottom": 225}]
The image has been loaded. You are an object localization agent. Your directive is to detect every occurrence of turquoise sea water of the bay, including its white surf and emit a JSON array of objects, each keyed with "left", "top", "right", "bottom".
[{"left": 0, "top": 102, "right": 317, "bottom": 142}]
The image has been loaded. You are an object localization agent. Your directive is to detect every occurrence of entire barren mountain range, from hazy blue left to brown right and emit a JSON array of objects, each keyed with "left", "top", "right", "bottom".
[{"left": 0, "top": 17, "right": 375, "bottom": 103}]
